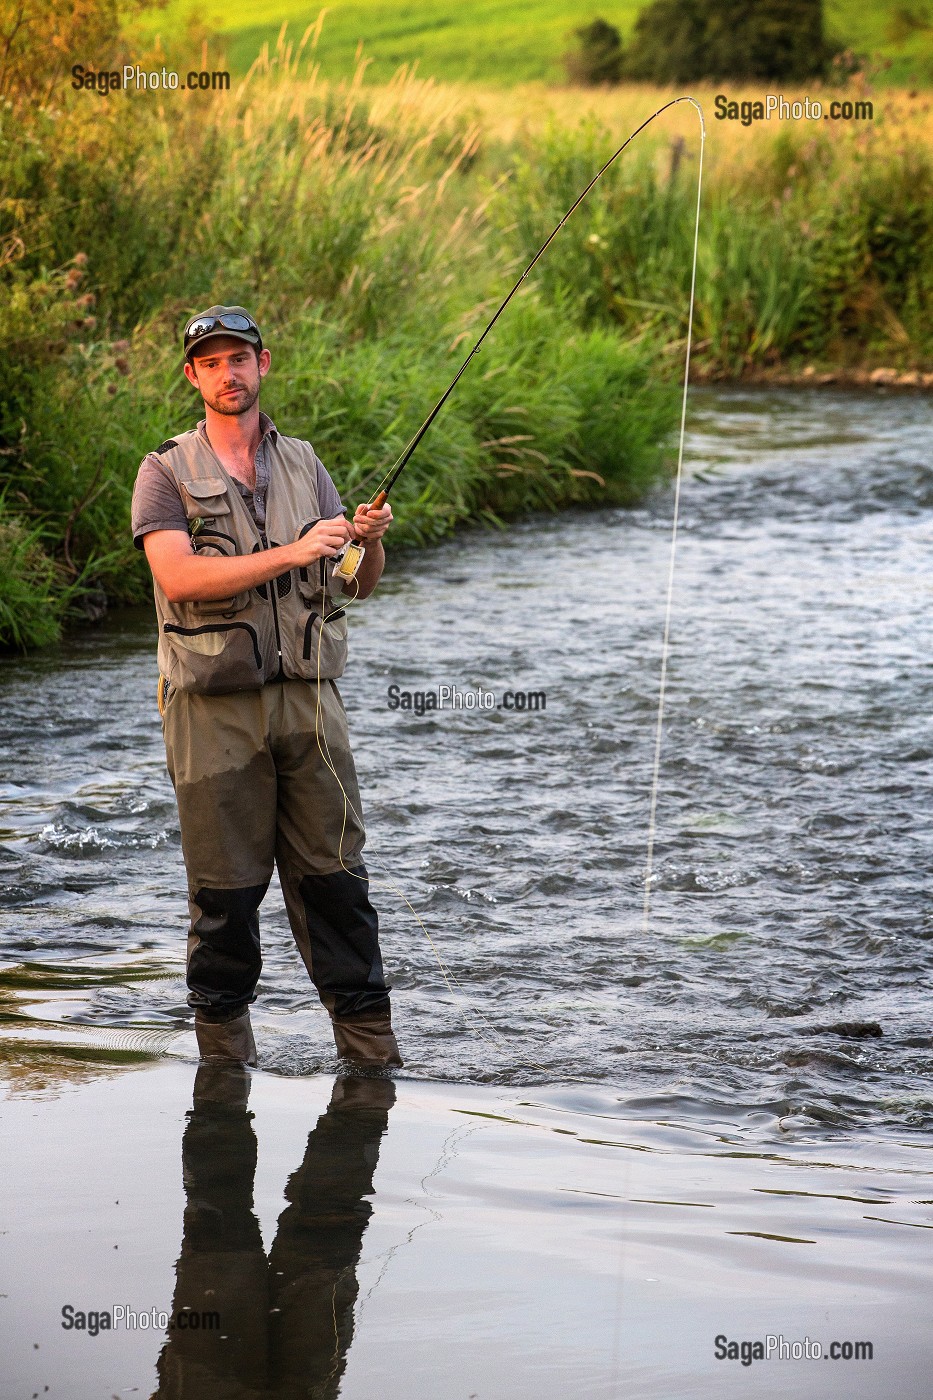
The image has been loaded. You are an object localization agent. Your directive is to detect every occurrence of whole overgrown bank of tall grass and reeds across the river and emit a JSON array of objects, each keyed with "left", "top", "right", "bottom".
[{"left": 0, "top": 11, "right": 933, "bottom": 647}]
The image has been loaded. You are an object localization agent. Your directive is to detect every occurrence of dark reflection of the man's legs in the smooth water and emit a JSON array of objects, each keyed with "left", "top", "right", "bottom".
[{"left": 153, "top": 1063, "right": 395, "bottom": 1400}]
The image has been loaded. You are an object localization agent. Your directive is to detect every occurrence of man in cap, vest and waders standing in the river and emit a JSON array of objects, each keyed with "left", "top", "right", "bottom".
[{"left": 133, "top": 307, "right": 402, "bottom": 1065}]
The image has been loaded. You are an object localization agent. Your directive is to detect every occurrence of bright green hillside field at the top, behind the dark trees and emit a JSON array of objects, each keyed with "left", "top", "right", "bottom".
[{"left": 137, "top": 0, "right": 933, "bottom": 87}]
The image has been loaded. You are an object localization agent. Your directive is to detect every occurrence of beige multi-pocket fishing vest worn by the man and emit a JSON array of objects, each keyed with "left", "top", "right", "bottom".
[{"left": 153, "top": 428, "right": 347, "bottom": 694}]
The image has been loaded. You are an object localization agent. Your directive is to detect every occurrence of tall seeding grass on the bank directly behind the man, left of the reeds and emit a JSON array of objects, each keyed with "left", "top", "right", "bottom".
[{"left": 0, "top": 49, "right": 675, "bottom": 644}]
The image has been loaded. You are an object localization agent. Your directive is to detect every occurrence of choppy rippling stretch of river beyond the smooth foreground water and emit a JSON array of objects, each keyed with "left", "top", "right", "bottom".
[{"left": 0, "top": 391, "right": 933, "bottom": 1127}]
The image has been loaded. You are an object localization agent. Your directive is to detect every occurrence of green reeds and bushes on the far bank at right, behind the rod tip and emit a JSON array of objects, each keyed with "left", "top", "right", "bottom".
[{"left": 495, "top": 95, "right": 933, "bottom": 375}]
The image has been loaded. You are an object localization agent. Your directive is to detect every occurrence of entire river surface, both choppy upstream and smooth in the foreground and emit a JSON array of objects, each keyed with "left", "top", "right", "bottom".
[{"left": 0, "top": 389, "right": 933, "bottom": 1400}]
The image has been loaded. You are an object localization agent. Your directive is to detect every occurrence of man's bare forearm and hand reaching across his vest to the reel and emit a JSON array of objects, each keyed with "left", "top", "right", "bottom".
[{"left": 143, "top": 515, "right": 350, "bottom": 603}]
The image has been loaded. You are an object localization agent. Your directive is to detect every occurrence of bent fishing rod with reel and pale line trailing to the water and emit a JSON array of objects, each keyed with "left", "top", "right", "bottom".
[{"left": 308, "top": 97, "right": 706, "bottom": 1064}]
